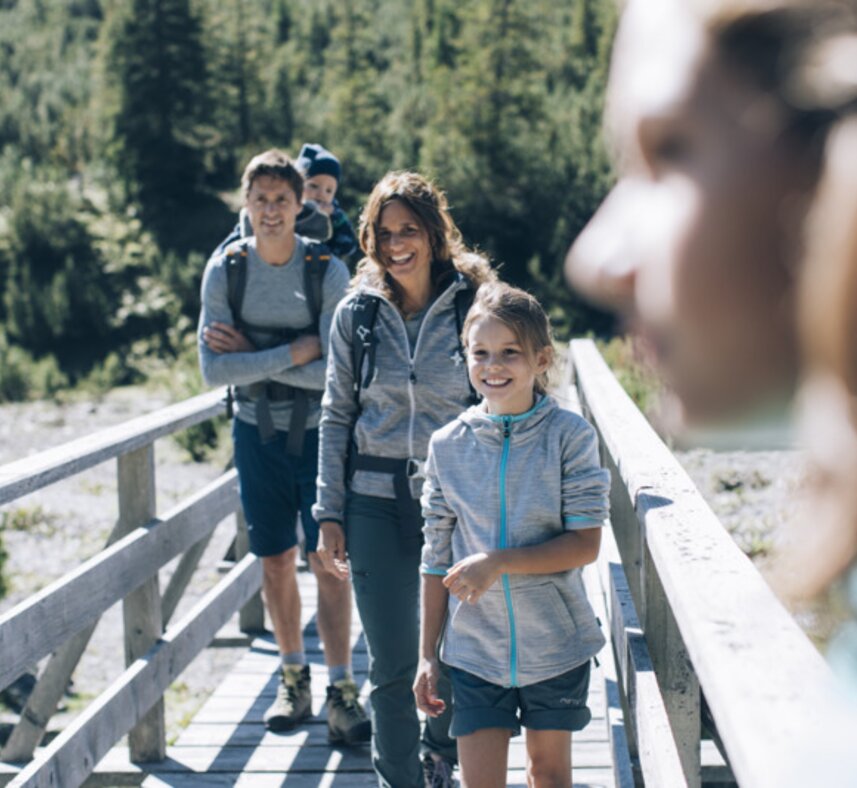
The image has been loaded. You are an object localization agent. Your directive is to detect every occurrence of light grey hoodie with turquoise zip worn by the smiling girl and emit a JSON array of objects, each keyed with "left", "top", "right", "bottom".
[{"left": 422, "top": 397, "right": 610, "bottom": 687}]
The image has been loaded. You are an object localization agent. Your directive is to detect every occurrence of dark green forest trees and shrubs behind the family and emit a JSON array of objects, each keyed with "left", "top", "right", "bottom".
[{"left": 0, "top": 0, "right": 617, "bottom": 400}]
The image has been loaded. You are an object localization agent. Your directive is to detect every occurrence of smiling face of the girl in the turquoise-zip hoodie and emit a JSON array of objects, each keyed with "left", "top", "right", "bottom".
[{"left": 466, "top": 317, "right": 549, "bottom": 415}]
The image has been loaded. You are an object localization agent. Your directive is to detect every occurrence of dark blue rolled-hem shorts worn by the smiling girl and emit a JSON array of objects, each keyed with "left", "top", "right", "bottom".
[{"left": 449, "top": 660, "right": 592, "bottom": 736}]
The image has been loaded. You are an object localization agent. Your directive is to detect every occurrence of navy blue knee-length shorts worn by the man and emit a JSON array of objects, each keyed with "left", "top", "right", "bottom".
[{"left": 232, "top": 419, "right": 318, "bottom": 556}]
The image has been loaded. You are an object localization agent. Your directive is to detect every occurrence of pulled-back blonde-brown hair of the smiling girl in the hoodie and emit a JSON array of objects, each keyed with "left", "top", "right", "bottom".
[{"left": 461, "top": 282, "right": 554, "bottom": 394}]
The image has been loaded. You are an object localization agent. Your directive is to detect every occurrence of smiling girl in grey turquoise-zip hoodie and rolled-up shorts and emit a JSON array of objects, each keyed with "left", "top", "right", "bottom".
[{"left": 414, "top": 284, "right": 609, "bottom": 788}]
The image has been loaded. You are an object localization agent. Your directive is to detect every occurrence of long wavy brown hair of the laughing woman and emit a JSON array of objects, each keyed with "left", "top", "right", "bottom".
[{"left": 352, "top": 171, "right": 497, "bottom": 307}]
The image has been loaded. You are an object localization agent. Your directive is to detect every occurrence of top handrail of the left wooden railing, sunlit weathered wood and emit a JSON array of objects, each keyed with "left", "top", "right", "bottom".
[{"left": 0, "top": 389, "right": 226, "bottom": 504}]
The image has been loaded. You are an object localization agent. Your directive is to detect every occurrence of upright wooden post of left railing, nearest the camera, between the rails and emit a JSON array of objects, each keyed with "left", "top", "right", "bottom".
[{"left": 117, "top": 444, "right": 167, "bottom": 762}]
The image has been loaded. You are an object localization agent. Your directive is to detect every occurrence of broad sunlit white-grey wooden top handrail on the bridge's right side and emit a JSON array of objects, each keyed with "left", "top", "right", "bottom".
[{"left": 571, "top": 340, "right": 857, "bottom": 788}]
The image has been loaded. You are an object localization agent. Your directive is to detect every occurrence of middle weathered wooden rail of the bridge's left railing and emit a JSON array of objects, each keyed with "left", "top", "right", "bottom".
[{"left": 0, "top": 471, "right": 238, "bottom": 688}]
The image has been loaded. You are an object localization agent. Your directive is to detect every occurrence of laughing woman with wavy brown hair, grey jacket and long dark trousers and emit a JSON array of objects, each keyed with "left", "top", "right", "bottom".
[{"left": 313, "top": 172, "right": 494, "bottom": 788}]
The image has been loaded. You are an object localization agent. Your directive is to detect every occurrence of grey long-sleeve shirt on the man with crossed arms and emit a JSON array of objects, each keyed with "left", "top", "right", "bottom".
[{"left": 198, "top": 236, "right": 349, "bottom": 430}]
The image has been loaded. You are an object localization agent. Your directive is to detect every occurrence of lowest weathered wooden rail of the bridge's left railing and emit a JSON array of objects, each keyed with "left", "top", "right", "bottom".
[{"left": 7, "top": 556, "right": 262, "bottom": 788}]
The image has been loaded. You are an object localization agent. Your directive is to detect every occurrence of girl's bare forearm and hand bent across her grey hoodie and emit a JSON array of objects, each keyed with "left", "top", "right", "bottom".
[{"left": 443, "top": 525, "right": 601, "bottom": 604}]
